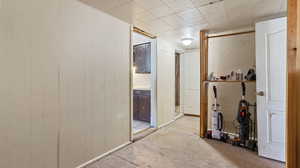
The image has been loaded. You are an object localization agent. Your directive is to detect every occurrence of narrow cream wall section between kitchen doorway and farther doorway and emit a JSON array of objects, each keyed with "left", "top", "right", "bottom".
[{"left": 157, "top": 38, "right": 175, "bottom": 126}]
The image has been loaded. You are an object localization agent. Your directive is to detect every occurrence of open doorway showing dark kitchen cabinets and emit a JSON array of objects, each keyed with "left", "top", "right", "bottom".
[{"left": 131, "top": 32, "right": 156, "bottom": 134}]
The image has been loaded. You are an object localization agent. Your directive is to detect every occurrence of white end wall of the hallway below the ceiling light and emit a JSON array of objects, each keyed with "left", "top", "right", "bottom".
[{"left": 181, "top": 49, "right": 200, "bottom": 115}]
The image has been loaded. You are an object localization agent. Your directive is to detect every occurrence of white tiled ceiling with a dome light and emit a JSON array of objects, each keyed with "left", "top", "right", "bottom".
[{"left": 81, "top": 0, "right": 287, "bottom": 48}]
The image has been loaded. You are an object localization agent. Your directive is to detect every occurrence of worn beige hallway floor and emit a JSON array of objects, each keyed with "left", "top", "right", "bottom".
[{"left": 86, "top": 117, "right": 284, "bottom": 168}]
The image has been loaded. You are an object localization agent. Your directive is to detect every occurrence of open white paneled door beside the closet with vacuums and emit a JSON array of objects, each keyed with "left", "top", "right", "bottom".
[{"left": 256, "top": 18, "right": 287, "bottom": 161}]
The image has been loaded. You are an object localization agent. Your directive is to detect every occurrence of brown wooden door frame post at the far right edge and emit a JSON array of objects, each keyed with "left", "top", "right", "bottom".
[{"left": 286, "top": 0, "right": 300, "bottom": 168}]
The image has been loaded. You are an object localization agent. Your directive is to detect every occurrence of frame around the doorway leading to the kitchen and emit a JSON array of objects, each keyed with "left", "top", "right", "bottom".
[{"left": 129, "top": 26, "right": 158, "bottom": 141}]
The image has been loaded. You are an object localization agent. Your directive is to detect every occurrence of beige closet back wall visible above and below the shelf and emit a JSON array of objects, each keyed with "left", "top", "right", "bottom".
[{"left": 208, "top": 34, "right": 256, "bottom": 132}]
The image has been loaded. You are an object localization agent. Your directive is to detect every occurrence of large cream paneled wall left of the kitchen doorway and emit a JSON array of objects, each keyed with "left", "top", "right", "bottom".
[{"left": 0, "top": 0, "right": 130, "bottom": 168}]
